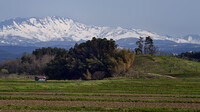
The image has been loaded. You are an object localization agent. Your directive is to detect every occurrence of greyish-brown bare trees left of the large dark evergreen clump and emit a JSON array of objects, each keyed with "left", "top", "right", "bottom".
[{"left": 0, "top": 47, "right": 67, "bottom": 75}]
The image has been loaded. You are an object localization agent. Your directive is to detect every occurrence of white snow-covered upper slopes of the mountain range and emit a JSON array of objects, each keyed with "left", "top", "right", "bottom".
[{"left": 0, "top": 17, "right": 200, "bottom": 45}]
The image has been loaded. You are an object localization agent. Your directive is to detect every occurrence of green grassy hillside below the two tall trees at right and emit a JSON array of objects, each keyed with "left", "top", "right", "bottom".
[{"left": 127, "top": 55, "right": 200, "bottom": 78}]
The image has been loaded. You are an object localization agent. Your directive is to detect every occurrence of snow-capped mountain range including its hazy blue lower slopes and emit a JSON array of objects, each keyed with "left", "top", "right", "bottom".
[{"left": 0, "top": 17, "right": 200, "bottom": 61}]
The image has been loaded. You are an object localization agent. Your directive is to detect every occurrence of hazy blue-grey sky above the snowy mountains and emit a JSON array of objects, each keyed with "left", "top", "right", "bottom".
[{"left": 0, "top": 0, "right": 200, "bottom": 36}]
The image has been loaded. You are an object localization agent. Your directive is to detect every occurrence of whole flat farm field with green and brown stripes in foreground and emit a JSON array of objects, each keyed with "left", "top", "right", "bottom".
[{"left": 0, "top": 78, "right": 200, "bottom": 112}]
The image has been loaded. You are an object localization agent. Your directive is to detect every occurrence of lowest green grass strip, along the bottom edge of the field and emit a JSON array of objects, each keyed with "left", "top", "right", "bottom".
[{"left": 0, "top": 105, "right": 200, "bottom": 112}]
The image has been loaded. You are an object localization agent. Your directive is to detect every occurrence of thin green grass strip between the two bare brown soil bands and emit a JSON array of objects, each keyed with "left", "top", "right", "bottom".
[{"left": 0, "top": 96, "right": 200, "bottom": 103}]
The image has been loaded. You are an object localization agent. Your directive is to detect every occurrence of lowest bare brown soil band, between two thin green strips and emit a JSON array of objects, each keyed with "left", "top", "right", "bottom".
[{"left": 0, "top": 100, "right": 200, "bottom": 109}]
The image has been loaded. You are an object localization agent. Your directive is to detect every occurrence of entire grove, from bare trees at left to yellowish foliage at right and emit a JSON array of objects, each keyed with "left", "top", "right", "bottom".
[{"left": 0, "top": 37, "right": 135, "bottom": 80}]
